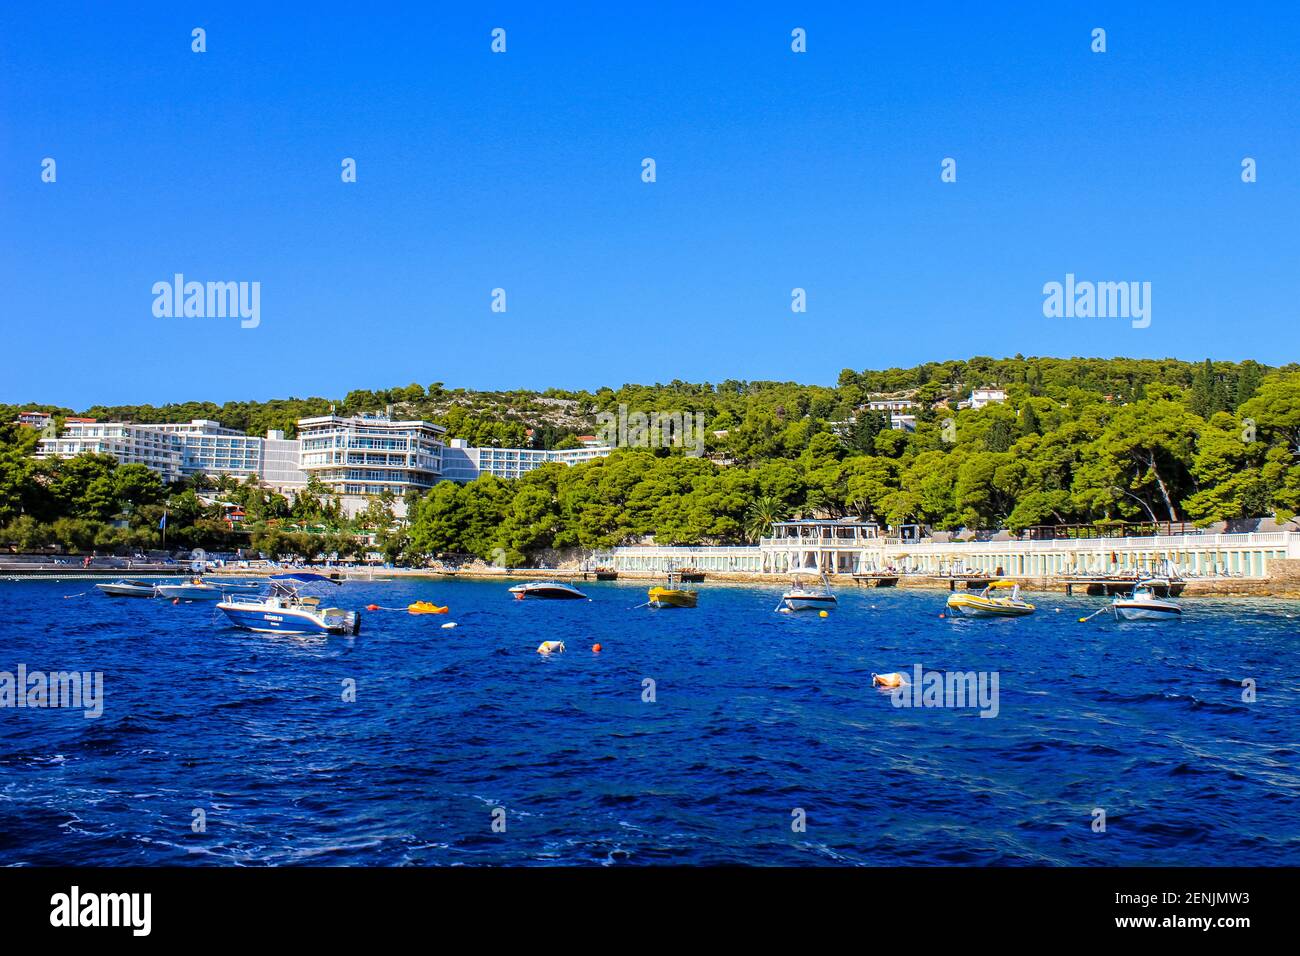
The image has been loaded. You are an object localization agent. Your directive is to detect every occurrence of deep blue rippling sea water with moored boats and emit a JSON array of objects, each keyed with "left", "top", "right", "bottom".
[{"left": 0, "top": 579, "right": 1300, "bottom": 865}]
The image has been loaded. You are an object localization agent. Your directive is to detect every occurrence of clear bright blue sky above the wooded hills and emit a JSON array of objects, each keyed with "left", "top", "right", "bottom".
[{"left": 0, "top": 3, "right": 1300, "bottom": 407}]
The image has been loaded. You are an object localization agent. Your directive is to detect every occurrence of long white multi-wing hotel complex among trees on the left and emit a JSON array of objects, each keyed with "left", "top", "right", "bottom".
[{"left": 35, "top": 415, "right": 614, "bottom": 514}]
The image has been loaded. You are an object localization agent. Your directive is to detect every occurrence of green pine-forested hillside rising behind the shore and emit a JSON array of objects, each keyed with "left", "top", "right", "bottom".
[{"left": 0, "top": 356, "right": 1300, "bottom": 563}]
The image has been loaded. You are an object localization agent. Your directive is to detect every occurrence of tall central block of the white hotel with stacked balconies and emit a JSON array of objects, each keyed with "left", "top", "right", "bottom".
[{"left": 298, "top": 415, "right": 447, "bottom": 510}]
